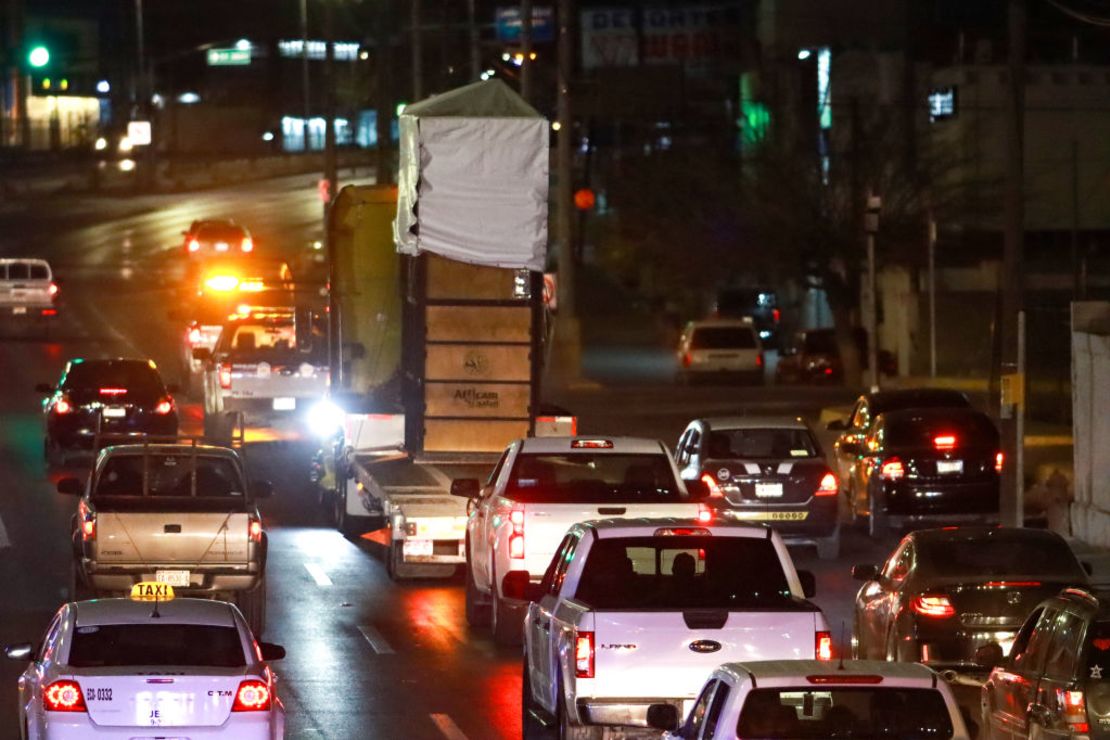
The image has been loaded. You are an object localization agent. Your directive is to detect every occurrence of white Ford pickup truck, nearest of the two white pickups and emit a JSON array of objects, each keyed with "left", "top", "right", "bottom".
[{"left": 515, "top": 519, "right": 833, "bottom": 738}]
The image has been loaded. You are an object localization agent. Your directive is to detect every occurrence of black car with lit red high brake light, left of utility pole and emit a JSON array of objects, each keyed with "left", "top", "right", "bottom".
[{"left": 846, "top": 408, "right": 1003, "bottom": 537}]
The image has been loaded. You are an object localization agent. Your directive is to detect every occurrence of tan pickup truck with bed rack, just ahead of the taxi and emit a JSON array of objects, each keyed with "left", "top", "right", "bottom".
[{"left": 58, "top": 444, "right": 270, "bottom": 633}]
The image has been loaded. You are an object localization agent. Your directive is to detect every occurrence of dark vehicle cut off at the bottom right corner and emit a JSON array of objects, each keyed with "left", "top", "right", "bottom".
[{"left": 980, "top": 588, "right": 1110, "bottom": 740}]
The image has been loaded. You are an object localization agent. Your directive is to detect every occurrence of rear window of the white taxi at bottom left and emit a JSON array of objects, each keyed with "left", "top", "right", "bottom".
[{"left": 69, "top": 625, "right": 246, "bottom": 668}]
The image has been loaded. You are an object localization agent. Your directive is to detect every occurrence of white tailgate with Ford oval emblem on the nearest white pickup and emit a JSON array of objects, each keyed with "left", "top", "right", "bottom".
[{"left": 583, "top": 609, "right": 819, "bottom": 698}]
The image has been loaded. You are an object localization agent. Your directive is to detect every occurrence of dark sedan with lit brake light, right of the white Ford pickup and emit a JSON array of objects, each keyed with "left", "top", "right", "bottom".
[{"left": 851, "top": 527, "right": 1087, "bottom": 669}]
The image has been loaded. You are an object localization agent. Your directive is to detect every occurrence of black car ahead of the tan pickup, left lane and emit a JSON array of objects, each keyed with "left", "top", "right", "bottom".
[{"left": 36, "top": 358, "right": 178, "bottom": 462}]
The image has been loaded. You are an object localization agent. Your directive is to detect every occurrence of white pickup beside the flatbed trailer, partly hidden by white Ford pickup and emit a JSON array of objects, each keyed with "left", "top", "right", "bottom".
[{"left": 451, "top": 437, "right": 712, "bottom": 645}]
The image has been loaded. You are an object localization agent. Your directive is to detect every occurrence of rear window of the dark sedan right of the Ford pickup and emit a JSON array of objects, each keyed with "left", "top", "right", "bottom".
[{"left": 917, "top": 536, "right": 1083, "bottom": 581}]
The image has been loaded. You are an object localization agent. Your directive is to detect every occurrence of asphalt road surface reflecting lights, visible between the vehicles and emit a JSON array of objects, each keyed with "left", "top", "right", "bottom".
[{"left": 0, "top": 176, "right": 910, "bottom": 740}]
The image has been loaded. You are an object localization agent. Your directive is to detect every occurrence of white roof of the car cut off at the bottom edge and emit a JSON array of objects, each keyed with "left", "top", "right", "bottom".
[{"left": 718, "top": 660, "right": 937, "bottom": 689}]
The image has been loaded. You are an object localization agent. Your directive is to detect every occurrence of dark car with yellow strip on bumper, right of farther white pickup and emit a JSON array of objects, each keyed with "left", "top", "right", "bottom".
[{"left": 675, "top": 416, "right": 840, "bottom": 559}]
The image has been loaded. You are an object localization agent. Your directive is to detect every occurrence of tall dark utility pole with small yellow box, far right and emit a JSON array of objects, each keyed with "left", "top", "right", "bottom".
[{"left": 999, "top": 0, "right": 1028, "bottom": 527}]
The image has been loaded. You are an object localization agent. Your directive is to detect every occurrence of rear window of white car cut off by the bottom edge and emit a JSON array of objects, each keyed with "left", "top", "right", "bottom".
[{"left": 736, "top": 687, "right": 952, "bottom": 740}]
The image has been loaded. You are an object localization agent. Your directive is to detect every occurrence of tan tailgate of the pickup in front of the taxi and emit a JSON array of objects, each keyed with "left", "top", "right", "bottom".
[{"left": 97, "top": 511, "right": 250, "bottom": 564}]
